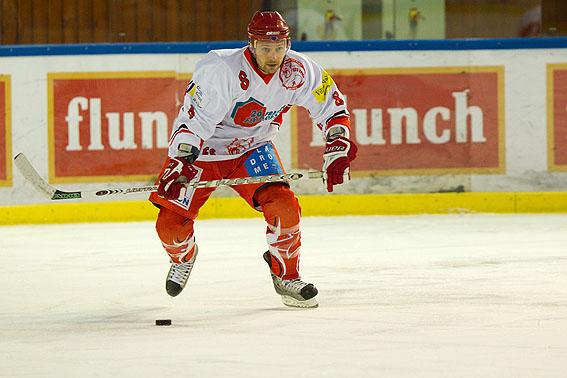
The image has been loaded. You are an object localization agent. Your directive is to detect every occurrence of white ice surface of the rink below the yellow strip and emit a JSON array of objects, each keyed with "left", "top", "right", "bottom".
[{"left": 0, "top": 214, "right": 567, "bottom": 378}]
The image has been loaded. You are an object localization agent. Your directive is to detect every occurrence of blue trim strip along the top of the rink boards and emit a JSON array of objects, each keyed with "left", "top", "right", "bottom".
[{"left": 0, "top": 37, "right": 567, "bottom": 57}]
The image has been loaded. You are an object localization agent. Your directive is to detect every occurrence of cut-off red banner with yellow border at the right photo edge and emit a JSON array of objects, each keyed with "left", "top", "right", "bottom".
[{"left": 547, "top": 64, "right": 567, "bottom": 172}]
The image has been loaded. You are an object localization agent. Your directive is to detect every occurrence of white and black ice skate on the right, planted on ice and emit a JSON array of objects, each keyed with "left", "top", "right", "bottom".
[{"left": 264, "top": 251, "right": 319, "bottom": 308}]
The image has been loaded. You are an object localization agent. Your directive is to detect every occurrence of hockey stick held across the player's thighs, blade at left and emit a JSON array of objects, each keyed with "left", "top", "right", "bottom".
[{"left": 14, "top": 153, "right": 323, "bottom": 200}]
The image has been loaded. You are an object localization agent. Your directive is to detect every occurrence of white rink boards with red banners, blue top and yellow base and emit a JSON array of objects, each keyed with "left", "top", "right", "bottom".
[{"left": 0, "top": 38, "right": 567, "bottom": 224}]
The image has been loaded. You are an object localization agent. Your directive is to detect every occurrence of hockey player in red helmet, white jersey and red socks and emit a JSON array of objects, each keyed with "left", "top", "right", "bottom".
[{"left": 150, "top": 12, "right": 357, "bottom": 307}]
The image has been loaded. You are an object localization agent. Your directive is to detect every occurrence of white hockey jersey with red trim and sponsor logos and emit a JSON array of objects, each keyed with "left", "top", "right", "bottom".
[{"left": 168, "top": 47, "right": 349, "bottom": 161}]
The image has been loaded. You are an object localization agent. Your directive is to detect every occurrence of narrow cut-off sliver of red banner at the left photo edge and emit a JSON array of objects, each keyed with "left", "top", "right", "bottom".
[{"left": 0, "top": 75, "right": 12, "bottom": 186}]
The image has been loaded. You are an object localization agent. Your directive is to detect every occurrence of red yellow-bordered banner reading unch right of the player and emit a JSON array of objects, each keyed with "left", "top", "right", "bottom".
[{"left": 292, "top": 67, "right": 505, "bottom": 176}]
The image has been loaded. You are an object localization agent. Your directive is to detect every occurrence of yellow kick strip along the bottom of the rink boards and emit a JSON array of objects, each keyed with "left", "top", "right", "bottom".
[{"left": 0, "top": 192, "right": 567, "bottom": 225}]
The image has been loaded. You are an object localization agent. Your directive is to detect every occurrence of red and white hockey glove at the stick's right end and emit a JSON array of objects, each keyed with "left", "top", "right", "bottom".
[{"left": 323, "top": 136, "right": 358, "bottom": 192}]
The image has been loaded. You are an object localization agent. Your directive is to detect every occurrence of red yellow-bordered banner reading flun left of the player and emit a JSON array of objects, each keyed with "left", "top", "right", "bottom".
[{"left": 48, "top": 71, "right": 190, "bottom": 182}]
